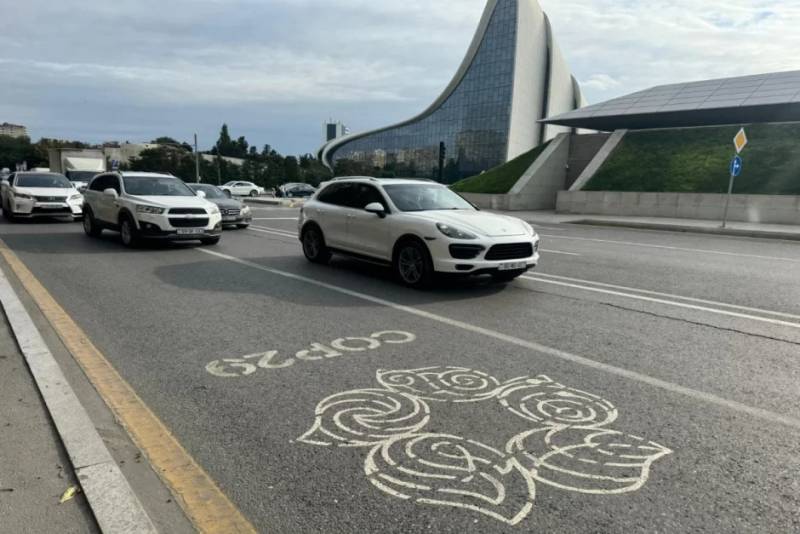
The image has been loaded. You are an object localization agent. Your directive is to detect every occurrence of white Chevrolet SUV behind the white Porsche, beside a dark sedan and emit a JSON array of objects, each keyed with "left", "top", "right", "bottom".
[{"left": 83, "top": 172, "right": 222, "bottom": 247}]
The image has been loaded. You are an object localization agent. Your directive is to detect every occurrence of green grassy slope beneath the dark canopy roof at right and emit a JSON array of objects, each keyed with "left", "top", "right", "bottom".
[{"left": 584, "top": 123, "right": 800, "bottom": 195}]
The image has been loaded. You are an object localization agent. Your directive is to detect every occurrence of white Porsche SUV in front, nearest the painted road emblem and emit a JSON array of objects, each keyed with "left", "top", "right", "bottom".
[{"left": 299, "top": 178, "right": 539, "bottom": 287}]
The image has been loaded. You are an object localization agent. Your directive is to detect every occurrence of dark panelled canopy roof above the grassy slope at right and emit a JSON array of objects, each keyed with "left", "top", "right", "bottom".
[{"left": 542, "top": 71, "right": 800, "bottom": 131}]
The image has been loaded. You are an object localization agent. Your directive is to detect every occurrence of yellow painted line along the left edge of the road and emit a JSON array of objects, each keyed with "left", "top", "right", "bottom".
[{"left": 0, "top": 239, "right": 256, "bottom": 534}]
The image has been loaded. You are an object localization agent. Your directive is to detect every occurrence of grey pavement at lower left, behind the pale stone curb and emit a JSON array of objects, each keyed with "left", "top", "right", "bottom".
[{"left": 0, "top": 311, "right": 99, "bottom": 534}]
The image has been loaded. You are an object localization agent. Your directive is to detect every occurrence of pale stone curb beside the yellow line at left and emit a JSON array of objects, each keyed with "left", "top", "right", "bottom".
[{"left": 0, "top": 271, "right": 157, "bottom": 534}]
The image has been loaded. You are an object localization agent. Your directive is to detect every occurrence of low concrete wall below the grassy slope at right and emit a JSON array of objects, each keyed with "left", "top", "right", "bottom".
[{"left": 556, "top": 191, "right": 800, "bottom": 224}]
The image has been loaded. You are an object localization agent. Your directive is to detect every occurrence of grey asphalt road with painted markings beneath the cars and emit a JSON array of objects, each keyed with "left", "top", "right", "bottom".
[{"left": 0, "top": 208, "right": 800, "bottom": 534}]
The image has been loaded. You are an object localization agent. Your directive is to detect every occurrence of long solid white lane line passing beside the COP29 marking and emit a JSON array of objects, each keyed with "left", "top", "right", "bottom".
[{"left": 194, "top": 248, "right": 800, "bottom": 430}]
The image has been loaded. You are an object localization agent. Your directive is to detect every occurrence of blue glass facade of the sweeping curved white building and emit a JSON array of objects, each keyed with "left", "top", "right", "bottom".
[{"left": 329, "top": 0, "right": 517, "bottom": 182}]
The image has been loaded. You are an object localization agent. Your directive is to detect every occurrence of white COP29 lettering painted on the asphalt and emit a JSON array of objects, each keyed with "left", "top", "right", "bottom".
[{"left": 206, "top": 330, "right": 417, "bottom": 378}]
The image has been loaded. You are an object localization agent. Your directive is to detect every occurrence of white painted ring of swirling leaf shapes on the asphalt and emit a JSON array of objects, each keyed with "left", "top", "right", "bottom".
[{"left": 298, "top": 367, "right": 672, "bottom": 525}]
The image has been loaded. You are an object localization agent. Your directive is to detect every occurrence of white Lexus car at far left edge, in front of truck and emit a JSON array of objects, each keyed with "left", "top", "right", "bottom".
[{"left": 0, "top": 172, "right": 83, "bottom": 220}]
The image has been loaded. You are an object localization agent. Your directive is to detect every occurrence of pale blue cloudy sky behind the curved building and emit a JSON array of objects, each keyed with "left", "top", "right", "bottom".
[{"left": 0, "top": 0, "right": 800, "bottom": 154}]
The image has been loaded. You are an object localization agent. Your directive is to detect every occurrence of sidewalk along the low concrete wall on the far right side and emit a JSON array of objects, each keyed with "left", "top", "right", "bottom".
[{"left": 498, "top": 211, "right": 800, "bottom": 241}]
